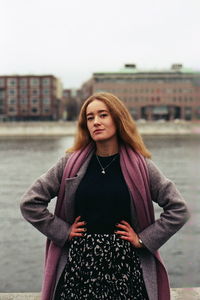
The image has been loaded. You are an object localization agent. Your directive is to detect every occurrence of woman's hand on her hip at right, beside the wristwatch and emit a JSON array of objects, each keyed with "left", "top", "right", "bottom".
[{"left": 115, "top": 220, "right": 142, "bottom": 248}]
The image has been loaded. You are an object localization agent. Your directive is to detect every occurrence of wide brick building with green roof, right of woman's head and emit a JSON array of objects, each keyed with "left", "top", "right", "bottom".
[{"left": 81, "top": 64, "right": 200, "bottom": 120}]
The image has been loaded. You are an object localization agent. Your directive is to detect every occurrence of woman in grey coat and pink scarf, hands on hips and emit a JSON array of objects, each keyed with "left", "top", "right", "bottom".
[{"left": 21, "top": 93, "right": 191, "bottom": 300}]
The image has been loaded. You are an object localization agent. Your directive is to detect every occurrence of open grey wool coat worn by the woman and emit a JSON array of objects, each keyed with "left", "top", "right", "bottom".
[{"left": 20, "top": 154, "right": 189, "bottom": 300}]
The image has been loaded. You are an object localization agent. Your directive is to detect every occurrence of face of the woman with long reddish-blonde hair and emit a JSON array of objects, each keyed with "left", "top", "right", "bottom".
[{"left": 86, "top": 100, "right": 117, "bottom": 142}]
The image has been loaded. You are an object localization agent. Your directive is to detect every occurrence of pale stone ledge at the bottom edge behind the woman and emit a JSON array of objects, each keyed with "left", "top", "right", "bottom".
[{"left": 0, "top": 288, "right": 200, "bottom": 300}]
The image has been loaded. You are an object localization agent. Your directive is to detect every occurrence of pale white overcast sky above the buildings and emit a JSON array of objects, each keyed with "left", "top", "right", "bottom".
[{"left": 0, "top": 0, "right": 200, "bottom": 88}]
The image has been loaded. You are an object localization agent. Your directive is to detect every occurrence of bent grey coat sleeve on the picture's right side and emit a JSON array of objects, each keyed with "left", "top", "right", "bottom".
[{"left": 139, "top": 159, "right": 189, "bottom": 253}]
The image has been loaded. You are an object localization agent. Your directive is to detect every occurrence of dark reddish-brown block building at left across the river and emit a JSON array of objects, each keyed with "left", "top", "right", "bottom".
[{"left": 0, "top": 75, "right": 62, "bottom": 121}]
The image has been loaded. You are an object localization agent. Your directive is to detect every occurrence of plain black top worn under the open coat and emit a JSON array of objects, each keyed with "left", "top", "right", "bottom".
[{"left": 75, "top": 154, "right": 131, "bottom": 233}]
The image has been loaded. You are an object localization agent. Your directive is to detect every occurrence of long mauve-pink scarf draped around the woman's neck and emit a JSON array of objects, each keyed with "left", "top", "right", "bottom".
[{"left": 41, "top": 144, "right": 170, "bottom": 300}]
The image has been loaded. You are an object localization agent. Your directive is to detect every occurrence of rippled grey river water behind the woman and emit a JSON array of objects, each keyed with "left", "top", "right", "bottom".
[{"left": 0, "top": 136, "right": 200, "bottom": 292}]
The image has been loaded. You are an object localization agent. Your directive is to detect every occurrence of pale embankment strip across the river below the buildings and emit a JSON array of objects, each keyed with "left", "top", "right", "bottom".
[{"left": 0, "top": 120, "right": 200, "bottom": 138}]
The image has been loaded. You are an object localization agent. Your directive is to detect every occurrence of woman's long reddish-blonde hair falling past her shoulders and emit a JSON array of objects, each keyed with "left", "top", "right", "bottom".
[{"left": 67, "top": 93, "right": 151, "bottom": 158}]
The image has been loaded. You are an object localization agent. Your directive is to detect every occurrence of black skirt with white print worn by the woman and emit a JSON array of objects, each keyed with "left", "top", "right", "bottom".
[{"left": 54, "top": 233, "right": 148, "bottom": 300}]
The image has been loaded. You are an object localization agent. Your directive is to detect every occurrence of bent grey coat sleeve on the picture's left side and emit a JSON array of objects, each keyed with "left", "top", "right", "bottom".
[{"left": 20, "top": 155, "right": 71, "bottom": 247}]
